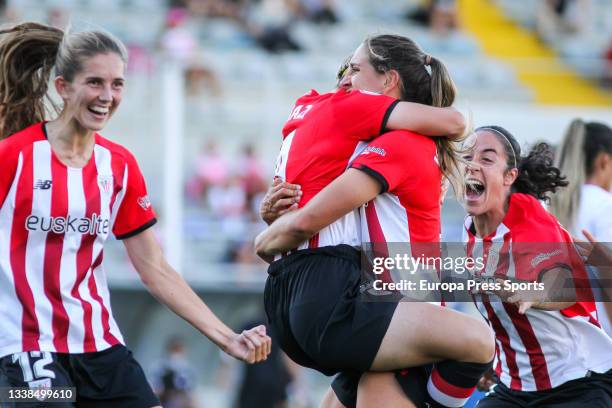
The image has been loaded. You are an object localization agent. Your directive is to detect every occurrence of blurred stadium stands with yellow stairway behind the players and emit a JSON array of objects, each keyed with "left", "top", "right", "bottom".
[{"left": 0, "top": 0, "right": 612, "bottom": 407}]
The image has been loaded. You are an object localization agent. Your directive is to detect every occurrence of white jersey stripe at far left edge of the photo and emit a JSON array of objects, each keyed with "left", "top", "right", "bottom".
[{"left": 0, "top": 154, "right": 23, "bottom": 354}]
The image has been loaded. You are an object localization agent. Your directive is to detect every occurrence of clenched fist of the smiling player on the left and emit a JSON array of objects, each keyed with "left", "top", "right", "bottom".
[{"left": 225, "top": 325, "right": 272, "bottom": 364}]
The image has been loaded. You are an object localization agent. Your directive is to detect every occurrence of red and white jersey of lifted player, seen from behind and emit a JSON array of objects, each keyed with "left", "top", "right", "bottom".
[{"left": 275, "top": 90, "right": 398, "bottom": 249}]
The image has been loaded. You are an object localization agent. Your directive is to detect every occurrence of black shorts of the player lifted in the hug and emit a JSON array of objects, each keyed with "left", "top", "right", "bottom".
[{"left": 264, "top": 245, "right": 397, "bottom": 375}]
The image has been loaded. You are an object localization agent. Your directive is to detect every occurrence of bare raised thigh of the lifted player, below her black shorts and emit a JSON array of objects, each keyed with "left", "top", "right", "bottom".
[{"left": 371, "top": 302, "right": 495, "bottom": 371}]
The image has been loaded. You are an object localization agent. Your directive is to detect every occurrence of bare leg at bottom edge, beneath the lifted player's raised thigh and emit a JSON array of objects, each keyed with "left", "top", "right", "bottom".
[{"left": 357, "top": 372, "right": 416, "bottom": 408}]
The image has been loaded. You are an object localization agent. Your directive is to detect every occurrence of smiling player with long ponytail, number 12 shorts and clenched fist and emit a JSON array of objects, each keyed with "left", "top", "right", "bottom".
[{"left": 0, "top": 23, "right": 270, "bottom": 407}]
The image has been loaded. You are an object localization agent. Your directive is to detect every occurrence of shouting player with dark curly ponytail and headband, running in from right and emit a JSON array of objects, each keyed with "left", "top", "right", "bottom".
[{"left": 360, "top": 126, "right": 612, "bottom": 408}]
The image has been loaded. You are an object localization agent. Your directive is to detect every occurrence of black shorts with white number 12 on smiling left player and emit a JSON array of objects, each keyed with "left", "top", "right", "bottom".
[{"left": 0, "top": 345, "right": 160, "bottom": 408}]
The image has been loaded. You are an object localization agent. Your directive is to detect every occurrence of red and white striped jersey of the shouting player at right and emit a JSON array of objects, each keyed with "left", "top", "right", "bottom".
[{"left": 465, "top": 193, "right": 612, "bottom": 391}]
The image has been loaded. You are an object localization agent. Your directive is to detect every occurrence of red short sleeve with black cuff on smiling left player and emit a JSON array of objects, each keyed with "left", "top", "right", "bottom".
[{"left": 113, "top": 155, "right": 157, "bottom": 239}]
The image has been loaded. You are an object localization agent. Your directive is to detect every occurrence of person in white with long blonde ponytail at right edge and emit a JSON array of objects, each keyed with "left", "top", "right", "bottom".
[{"left": 550, "top": 119, "right": 612, "bottom": 335}]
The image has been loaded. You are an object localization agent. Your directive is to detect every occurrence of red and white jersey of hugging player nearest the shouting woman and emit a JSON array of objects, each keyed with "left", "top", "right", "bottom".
[{"left": 350, "top": 130, "right": 442, "bottom": 281}]
